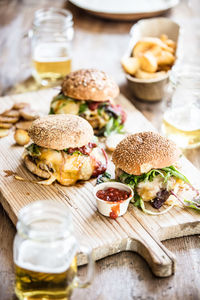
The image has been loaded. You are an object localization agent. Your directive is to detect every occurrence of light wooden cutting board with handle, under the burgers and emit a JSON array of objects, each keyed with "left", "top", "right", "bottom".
[{"left": 0, "top": 89, "right": 200, "bottom": 277}]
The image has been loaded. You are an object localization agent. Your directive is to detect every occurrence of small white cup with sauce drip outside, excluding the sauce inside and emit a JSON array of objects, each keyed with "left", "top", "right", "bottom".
[{"left": 93, "top": 182, "right": 134, "bottom": 217}]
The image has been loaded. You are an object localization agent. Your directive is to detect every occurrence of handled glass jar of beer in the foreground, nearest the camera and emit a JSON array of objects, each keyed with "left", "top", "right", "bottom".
[{"left": 14, "top": 201, "right": 94, "bottom": 300}]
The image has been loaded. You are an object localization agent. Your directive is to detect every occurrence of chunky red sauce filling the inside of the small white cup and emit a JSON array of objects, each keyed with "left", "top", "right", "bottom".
[{"left": 96, "top": 187, "right": 130, "bottom": 202}]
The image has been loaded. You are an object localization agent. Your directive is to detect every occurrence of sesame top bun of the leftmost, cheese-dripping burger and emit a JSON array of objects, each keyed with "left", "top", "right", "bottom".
[{"left": 28, "top": 115, "right": 93, "bottom": 150}]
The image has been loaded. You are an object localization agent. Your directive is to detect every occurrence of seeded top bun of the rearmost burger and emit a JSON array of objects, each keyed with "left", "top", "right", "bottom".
[{"left": 62, "top": 69, "right": 119, "bottom": 102}]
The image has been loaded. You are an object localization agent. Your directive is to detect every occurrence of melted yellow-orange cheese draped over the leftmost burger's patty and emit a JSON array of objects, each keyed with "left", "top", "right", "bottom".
[{"left": 34, "top": 148, "right": 105, "bottom": 186}]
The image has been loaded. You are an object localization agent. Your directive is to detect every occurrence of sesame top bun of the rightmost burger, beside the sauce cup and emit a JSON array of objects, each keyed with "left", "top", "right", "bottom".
[{"left": 112, "top": 132, "right": 181, "bottom": 175}]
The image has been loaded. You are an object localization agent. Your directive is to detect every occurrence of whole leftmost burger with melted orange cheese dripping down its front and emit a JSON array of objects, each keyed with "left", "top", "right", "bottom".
[{"left": 23, "top": 115, "right": 107, "bottom": 186}]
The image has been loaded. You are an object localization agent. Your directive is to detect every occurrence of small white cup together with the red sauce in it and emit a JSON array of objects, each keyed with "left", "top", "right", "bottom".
[{"left": 94, "top": 182, "right": 133, "bottom": 219}]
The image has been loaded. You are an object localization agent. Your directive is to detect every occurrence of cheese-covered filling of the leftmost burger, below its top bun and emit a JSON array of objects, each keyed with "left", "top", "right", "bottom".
[{"left": 23, "top": 146, "right": 106, "bottom": 186}]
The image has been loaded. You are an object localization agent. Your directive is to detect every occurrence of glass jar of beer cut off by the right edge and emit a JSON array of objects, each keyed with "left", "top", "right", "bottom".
[{"left": 162, "top": 64, "right": 200, "bottom": 149}]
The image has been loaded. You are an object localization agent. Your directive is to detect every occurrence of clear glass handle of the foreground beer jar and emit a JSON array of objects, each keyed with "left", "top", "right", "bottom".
[{"left": 77, "top": 246, "right": 94, "bottom": 288}]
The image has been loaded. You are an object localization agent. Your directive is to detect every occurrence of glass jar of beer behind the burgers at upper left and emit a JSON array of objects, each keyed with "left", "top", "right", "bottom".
[{"left": 29, "top": 7, "right": 74, "bottom": 86}]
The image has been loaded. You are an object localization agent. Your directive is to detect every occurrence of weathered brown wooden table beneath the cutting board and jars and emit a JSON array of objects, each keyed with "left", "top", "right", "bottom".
[{"left": 0, "top": 0, "right": 200, "bottom": 300}]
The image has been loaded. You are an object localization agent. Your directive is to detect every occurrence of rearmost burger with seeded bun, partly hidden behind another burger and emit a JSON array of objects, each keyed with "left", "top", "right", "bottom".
[{"left": 50, "top": 69, "right": 126, "bottom": 136}]
